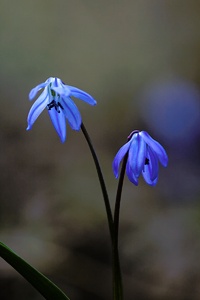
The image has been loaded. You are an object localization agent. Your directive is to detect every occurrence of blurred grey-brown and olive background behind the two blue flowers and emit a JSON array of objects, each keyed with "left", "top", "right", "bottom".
[{"left": 0, "top": 0, "right": 200, "bottom": 300}]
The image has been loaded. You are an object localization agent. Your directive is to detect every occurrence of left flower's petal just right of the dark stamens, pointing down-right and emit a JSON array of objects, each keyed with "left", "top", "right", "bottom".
[{"left": 60, "top": 97, "right": 82, "bottom": 130}]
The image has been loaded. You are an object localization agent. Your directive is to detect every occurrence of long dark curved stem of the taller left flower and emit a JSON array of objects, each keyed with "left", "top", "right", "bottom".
[{"left": 81, "top": 123, "right": 123, "bottom": 300}]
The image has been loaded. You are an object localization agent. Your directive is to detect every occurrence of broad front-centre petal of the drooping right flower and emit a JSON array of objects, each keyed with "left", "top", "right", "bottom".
[{"left": 128, "top": 133, "right": 146, "bottom": 177}]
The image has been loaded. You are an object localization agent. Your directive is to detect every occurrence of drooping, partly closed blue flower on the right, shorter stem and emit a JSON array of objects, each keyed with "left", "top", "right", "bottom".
[{"left": 113, "top": 130, "right": 168, "bottom": 185}]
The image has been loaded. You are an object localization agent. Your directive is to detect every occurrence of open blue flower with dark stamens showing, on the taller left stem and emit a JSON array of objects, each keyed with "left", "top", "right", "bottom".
[{"left": 26, "top": 77, "right": 96, "bottom": 143}]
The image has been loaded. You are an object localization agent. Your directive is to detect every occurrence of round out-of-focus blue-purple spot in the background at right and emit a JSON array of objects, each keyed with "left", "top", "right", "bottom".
[{"left": 141, "top": 78, "right": 200, "bottom": 146}]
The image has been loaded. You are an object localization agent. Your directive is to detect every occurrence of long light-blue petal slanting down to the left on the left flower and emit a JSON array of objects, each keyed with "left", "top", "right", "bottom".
[{"left": 26, "top": 88, "right": 49, "bottom": 130}]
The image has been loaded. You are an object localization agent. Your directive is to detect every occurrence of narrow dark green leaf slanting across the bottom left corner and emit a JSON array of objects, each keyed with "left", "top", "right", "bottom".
[{"left": 0, "top": 242, "right": 69, "bottom": 300}]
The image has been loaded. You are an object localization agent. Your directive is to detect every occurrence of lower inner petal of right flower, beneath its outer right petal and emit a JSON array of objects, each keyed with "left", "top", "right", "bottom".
[{"left": 142, "top": 148, "right": 159, "bottom": 185}]
